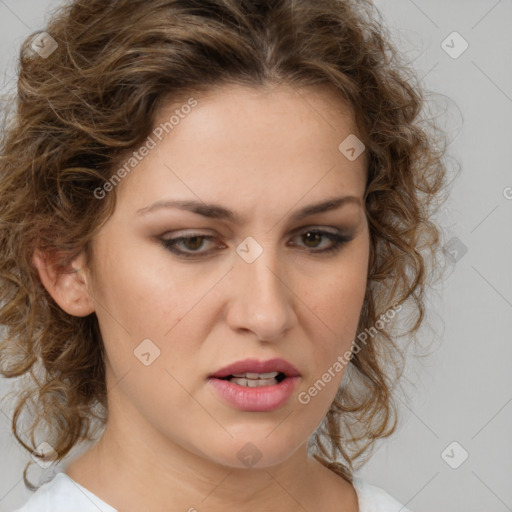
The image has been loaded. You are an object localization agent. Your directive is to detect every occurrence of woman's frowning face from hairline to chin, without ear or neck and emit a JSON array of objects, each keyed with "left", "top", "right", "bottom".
[{"left": 81, "top": 82, "right": 369, "bottom": 467}]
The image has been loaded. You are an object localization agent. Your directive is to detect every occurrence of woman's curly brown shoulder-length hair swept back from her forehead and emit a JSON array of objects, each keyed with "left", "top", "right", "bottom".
[{"left": 0, "top": 0, "right": 446, "bottom": 490}]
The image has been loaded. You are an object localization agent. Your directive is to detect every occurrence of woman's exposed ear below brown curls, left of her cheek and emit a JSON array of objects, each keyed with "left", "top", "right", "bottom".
[{"left": 32, "top": 249, "right": 95, "bottom": 316}]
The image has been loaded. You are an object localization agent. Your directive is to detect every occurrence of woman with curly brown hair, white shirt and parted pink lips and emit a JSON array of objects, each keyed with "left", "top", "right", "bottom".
[{"left": 0, "top": 0, "right": 445, "bottom": 512}]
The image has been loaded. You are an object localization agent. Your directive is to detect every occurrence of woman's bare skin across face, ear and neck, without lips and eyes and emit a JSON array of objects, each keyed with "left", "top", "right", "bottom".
[{"left": 34, "top": 85, "right": 369, "bottom": 512}]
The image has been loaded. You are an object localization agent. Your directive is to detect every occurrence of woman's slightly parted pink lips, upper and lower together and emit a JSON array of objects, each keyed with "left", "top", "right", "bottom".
[{"left": 208, "top": 359, "right": 300, "bottom": 412}]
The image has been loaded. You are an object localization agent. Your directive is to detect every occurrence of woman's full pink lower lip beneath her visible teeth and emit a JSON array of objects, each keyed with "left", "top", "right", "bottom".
[{"left": 208, "top": 377, "right": 300, "bottom": 412}]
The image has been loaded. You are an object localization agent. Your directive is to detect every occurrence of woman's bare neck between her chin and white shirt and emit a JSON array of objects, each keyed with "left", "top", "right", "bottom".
[{"left": 65, "top": 370, "right": 357, "bottom": 512}]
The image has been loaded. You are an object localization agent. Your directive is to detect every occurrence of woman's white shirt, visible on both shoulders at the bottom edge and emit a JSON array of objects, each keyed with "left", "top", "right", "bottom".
[{"left": 13, "top": 472, "right": 411, "bottom": 512}]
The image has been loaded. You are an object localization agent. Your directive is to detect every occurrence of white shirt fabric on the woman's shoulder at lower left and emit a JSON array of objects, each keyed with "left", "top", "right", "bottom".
[{"left": 13, "top": 473, "right": 117, "bottom": 512}]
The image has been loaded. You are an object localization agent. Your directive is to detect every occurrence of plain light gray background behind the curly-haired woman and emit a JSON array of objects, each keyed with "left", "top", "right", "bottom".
[{"left": 0, "top": 0, "right": 512, "bottom": 512}]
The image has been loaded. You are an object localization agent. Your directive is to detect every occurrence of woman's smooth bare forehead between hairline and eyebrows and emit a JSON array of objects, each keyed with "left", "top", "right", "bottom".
[{"left": 114, "top": 85, "right": 366, "bottom": 215}]
